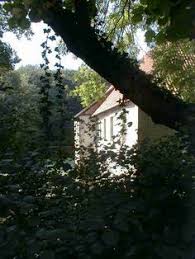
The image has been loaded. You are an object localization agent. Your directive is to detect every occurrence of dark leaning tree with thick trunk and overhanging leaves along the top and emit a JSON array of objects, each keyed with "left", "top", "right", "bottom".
[{"left": 1, "top": 0, "right": 195, "bottom": 256}]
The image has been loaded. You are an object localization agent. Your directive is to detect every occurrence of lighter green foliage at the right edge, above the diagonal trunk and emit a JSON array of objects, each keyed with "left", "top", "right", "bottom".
[{"left": 151, "top": 40, "right": 195, "bottom": 102}]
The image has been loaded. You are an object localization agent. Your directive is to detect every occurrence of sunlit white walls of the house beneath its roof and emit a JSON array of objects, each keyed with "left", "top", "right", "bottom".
[{"left": 75, "top": 102, "right": 174, "bottom": 154}]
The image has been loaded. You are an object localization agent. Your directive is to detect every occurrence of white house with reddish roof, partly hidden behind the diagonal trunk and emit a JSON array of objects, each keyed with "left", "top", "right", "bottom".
[{"left": 75, "top": 55, "right": 174, "bottom": 161}]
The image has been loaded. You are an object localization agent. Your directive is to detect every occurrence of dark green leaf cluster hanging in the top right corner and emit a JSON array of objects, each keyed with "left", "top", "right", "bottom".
[{"left": 129, "top": 0, "right": 194, "bottom": 42}]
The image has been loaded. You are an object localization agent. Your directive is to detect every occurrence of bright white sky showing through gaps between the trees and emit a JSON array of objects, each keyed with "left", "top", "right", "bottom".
[{"left": 3, "top": 22, "right": 148, "bottom": 70}]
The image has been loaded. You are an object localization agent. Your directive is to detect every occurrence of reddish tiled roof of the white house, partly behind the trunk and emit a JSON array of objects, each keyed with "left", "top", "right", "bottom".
[{"left": 75, "top": 54, "right": 153, "bottom": 118}]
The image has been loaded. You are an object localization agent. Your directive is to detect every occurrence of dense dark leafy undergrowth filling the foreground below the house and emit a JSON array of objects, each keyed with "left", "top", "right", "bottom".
[{"left": 0, "top": 138, "right": 190, "bottom": 259}]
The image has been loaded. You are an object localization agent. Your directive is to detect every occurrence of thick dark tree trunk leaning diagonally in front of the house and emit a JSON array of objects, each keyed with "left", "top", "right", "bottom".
[{"left": 44, "top": 5, "right": 192, "bottom": 132}]
